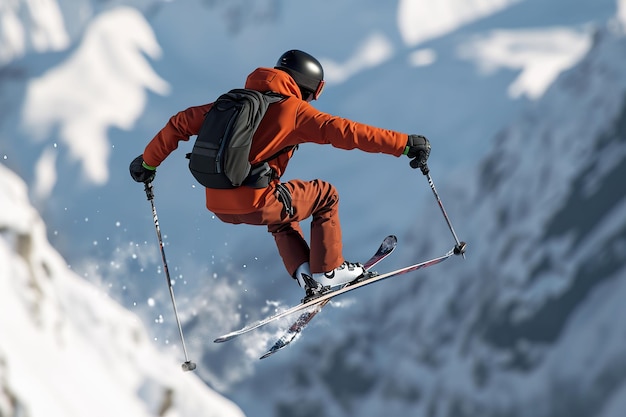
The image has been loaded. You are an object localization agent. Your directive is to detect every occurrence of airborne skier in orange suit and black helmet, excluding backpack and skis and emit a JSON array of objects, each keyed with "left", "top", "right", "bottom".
[{"left": 130, "top": 50, "right": 430, "bottom": 295}]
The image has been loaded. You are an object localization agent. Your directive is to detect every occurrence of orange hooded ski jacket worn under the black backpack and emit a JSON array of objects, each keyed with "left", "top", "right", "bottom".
[{"left": 143, "top": 68, "right": 408, "bottom": 214}]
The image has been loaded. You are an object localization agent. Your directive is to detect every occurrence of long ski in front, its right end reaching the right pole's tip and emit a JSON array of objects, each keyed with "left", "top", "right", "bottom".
[{"left": 214, "top": 239, "right": 461, "bottom": 343}]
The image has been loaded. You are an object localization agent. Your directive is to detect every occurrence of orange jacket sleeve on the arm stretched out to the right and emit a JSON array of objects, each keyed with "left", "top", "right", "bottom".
[{"left": 294, "top": 102, "right": 408, "bottom": 156}]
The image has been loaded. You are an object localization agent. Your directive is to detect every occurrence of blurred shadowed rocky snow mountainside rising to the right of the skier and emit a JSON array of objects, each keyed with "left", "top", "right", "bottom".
[{"left": 232, "top": 14, "right": 626, "bottom": 417}]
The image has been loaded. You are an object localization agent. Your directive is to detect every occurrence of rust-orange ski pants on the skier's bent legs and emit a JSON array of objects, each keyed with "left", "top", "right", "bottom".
[{"left": 215, "top": 180, "right": 344, "bottom": 276}]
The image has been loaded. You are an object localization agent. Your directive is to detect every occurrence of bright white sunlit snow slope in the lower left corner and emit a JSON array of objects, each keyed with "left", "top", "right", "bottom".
[{"left": 0, "top": 165, "right": 243, "bottom": 417}]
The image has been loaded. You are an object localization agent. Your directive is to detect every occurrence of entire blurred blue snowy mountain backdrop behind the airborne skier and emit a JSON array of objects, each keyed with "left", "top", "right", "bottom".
[{"left": 0, "top": 0, "right": 626, "bottom": 417}]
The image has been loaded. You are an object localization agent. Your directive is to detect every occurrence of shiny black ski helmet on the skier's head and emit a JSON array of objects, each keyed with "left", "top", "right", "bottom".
[{"left": 274, "top": 49, "right": 324, "bottom": 100}]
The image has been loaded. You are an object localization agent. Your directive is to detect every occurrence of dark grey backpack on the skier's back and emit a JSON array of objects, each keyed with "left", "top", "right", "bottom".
[{"left": 187, "top": 89, "right": 284, "bottom": 189}]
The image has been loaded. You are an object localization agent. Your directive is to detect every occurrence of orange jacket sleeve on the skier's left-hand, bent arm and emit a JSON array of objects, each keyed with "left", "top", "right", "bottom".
[{"left": 143, "top": 103, "right": 212, "bottom": 167}]
